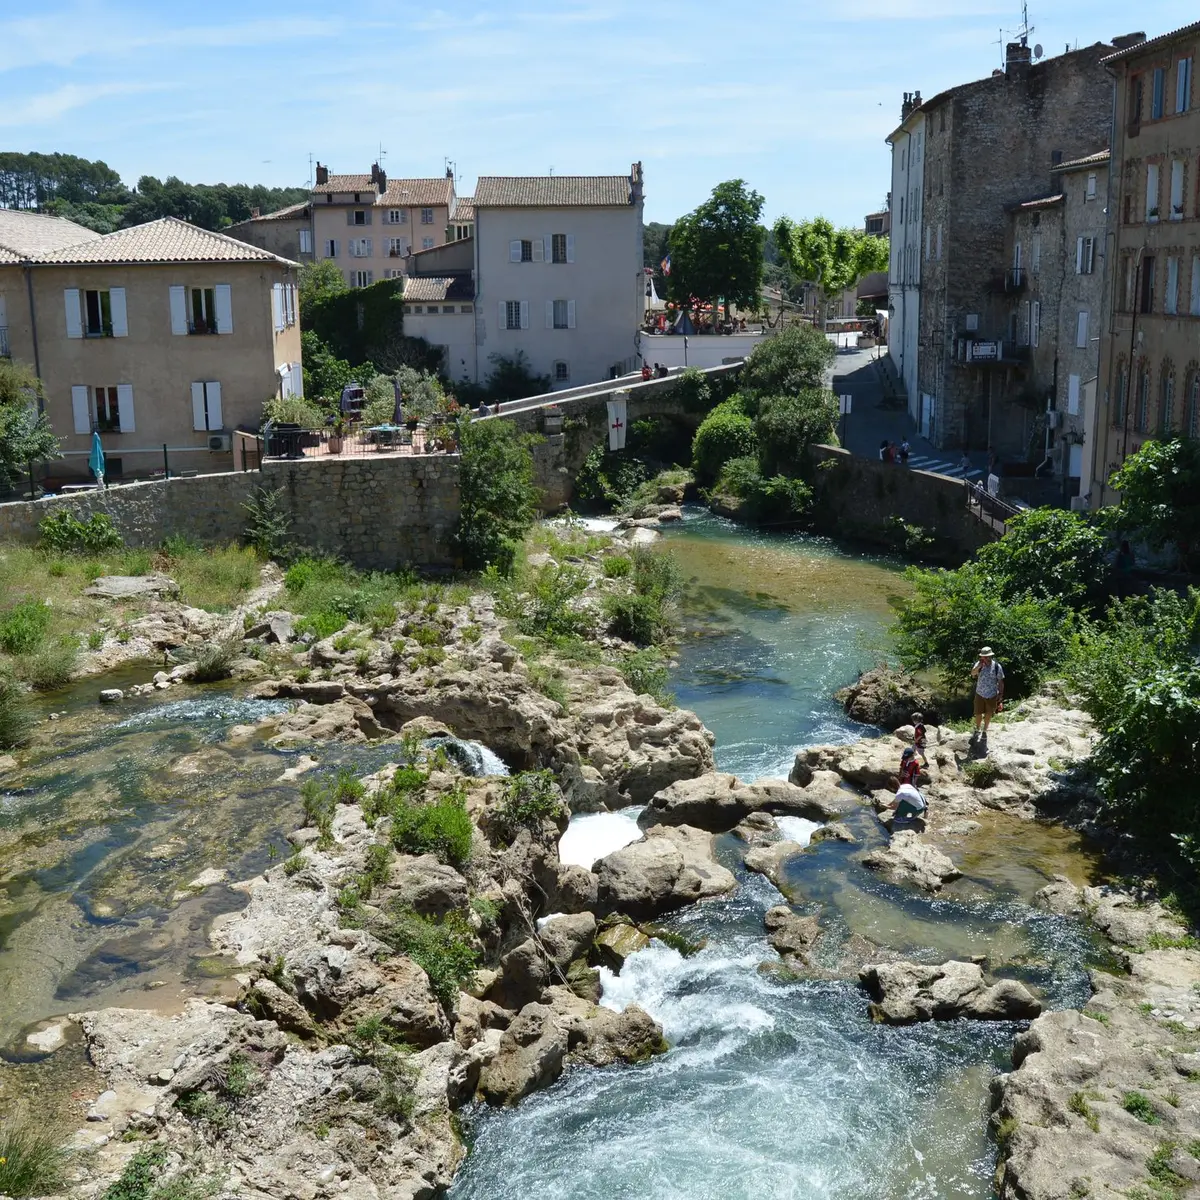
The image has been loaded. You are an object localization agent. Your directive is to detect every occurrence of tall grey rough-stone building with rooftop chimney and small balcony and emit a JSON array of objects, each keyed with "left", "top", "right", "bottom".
[{"left": 889, "top": 41, "right": 1115, "bottom": 461}]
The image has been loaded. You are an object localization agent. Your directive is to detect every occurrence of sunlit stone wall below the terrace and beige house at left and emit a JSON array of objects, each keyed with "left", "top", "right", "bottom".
[{"left": 0, "top": 455, "right": 458, "bottom": 570}]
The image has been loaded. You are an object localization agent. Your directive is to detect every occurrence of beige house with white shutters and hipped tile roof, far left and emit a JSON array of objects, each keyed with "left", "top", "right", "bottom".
[{"left": 0, "top": 217, "right": 302, "bottom": 478}]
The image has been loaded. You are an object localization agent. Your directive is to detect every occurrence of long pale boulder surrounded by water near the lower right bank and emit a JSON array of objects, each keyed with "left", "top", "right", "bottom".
[{"left": 858, "top": 960, "right": 1042, "bottom": 1025}]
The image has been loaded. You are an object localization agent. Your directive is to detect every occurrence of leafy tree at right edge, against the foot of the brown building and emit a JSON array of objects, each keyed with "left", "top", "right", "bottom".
[{"left": 1108, "top": 438, "right": 1200, "bottom": 568}]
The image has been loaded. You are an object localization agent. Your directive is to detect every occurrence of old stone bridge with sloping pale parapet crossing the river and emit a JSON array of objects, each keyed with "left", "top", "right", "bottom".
[{"left": 486, "top": 362, "right": 742, "bottom": 512}]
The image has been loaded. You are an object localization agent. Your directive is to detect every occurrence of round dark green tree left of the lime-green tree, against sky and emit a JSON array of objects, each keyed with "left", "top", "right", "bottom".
[{"left": 667, "top": 179, "right": 767, "bottom": 317}]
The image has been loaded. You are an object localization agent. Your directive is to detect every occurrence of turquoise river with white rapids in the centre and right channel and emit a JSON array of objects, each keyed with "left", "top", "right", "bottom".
[{"left": 451, "top": 514, "right": 1098, "bottom": 1200}]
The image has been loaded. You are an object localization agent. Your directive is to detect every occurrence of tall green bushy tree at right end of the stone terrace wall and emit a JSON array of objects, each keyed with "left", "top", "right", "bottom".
[{"left": 455, "top": 413, "right": 539, "bottom": 575}]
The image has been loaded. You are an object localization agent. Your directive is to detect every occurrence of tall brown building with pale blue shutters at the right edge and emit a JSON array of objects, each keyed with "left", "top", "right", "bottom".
[{"left": 1091, "top": 22, "right": 1200, "bottom": 505}]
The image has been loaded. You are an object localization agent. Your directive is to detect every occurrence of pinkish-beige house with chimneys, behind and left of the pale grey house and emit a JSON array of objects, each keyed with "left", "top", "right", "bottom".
[{"left": 312, "top": 163, "right": 456, "bottom": 288}]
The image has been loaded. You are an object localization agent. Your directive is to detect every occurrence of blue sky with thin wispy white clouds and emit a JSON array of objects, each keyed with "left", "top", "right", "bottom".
[{"left": 0, "top": 0, "right": 1195, "bottom": 224}]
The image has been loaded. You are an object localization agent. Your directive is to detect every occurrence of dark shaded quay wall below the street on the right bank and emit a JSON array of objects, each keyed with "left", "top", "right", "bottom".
[{"left": 809, "top": 445, "right": 998, "bottom": 565}]
